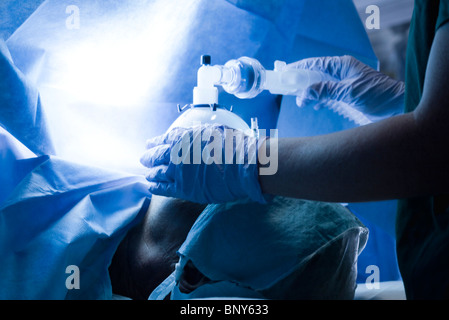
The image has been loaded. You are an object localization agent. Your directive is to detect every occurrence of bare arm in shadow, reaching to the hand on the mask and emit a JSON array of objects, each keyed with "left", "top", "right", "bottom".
[{"left": 259, "top": 24, "right": 449, "bottom": 202}]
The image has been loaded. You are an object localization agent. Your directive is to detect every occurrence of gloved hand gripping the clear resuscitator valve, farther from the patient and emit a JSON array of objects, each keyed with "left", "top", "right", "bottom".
[{"left": 288, "top": 56, "right": 405, "bottom": 122}]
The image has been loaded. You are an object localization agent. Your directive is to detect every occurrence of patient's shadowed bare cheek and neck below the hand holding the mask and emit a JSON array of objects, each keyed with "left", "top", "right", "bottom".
[{"left": 109, "top": 196, "right": 206, "bottom": 299}]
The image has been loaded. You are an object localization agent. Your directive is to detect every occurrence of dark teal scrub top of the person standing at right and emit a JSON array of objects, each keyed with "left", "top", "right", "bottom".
[{"left": 396, "top": 0, "right": 449, "bottom": 299}]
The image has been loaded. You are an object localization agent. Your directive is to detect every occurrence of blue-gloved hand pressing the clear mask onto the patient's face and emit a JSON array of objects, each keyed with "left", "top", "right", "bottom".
[{"left": 140, "top": 125, "right": 265, "bottom": 203}]
